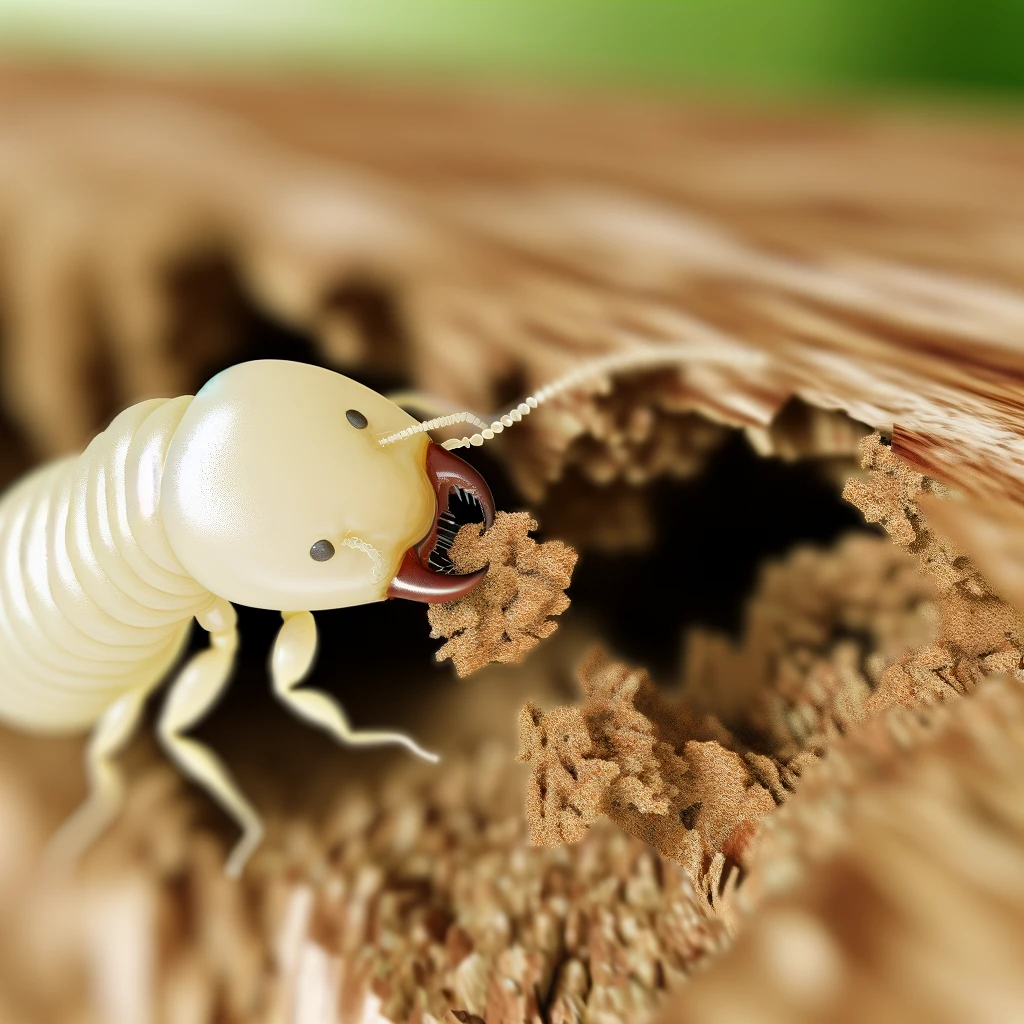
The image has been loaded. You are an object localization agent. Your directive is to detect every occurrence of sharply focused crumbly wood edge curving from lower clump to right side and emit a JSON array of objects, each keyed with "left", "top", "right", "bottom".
[{"left": 520, "top": 432, "right": 1024, "bottom": 916}]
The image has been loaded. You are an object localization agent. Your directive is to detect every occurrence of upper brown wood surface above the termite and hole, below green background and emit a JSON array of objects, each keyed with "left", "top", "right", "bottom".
[{"left": 0, "top": 69, "right": 1024, "bottom": 603}]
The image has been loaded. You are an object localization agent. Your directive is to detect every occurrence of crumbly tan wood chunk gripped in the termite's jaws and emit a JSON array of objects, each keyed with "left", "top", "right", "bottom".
[{"left": 427, "top": 512, "right": 577, "bottom": 676}]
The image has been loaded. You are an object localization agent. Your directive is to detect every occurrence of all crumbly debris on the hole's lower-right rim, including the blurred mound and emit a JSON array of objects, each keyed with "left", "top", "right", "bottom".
[{"left": 520, "top": 433, "right": 1024, "bottom": 904}]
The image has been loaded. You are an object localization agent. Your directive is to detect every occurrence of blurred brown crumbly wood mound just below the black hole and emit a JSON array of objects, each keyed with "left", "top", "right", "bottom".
[{"left": 683, "top": 534, "right": 939, "bottom": 761}]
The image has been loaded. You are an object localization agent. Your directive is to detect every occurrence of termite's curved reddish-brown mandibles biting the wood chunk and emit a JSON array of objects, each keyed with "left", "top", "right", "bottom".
[{"left": 387, "top": 443, "right": 495, "bottom": 604}]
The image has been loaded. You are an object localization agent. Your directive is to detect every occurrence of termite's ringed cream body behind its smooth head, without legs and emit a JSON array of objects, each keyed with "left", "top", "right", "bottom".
[{"left": 0, "top": 397, "right": 213, "bottom": 732}]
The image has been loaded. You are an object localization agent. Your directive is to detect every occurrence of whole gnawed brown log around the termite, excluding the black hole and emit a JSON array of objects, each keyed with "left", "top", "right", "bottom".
[{"left": 0, "top": 70, "right": 1024, "bottom": 1024}]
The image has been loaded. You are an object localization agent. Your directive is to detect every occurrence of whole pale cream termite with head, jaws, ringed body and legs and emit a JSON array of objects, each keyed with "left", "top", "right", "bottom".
[{"left": 0, "top": 360, "right": 494, "bottom": 873}]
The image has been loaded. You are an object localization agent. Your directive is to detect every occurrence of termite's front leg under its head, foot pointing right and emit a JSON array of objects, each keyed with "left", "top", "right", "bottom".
[{"left": 270, "top": 611, "right": 438, "bottom": 761}]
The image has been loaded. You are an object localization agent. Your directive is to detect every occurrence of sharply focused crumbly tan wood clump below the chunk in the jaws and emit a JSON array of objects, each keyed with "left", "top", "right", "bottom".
[{"left": 519, "top": 648, "right": 775, "bottom": 890}]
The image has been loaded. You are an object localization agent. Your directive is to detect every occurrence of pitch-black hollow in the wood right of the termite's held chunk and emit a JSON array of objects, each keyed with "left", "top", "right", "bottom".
[{"left": 569, "top": 433, "right": 877, "bottom": 680}]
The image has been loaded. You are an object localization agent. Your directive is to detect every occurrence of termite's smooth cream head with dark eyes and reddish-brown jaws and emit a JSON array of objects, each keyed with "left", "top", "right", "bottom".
[{"left": 160, "top": 359, "right": 494, "bottom": 611}]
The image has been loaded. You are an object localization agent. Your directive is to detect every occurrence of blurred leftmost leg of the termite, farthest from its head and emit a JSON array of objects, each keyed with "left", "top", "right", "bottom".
[{"left": 47, "top": 688, "right": 150, "bottom": 869}]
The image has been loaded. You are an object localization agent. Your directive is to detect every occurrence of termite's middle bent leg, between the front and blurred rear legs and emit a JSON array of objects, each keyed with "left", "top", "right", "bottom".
[{"left": 158, "top": 599, "right": 263, "bottom": 878}]
